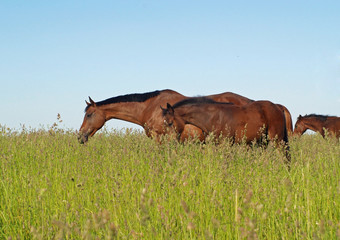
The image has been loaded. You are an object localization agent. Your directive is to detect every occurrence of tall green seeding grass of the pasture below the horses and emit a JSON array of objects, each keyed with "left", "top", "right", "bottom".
[{"left": 0, "top": 126, "right": 340, "bottom": 239}]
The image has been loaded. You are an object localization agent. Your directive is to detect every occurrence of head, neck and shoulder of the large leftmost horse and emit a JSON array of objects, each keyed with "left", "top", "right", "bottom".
[{"left": 78, "top": 90, "right": 185, "bottom": 143}]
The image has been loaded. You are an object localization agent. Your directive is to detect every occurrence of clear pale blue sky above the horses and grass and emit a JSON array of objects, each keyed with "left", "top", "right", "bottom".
[{"left": 0, "top": 0, "right": 340, "bottom": 129}]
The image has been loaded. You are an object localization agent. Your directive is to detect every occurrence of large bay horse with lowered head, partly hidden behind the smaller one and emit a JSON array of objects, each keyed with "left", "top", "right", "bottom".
[{"left": 78, "top": 89, "right": 291, "bottom": 143}]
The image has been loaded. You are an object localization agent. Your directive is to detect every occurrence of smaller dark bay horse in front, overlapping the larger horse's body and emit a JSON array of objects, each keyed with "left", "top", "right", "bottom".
[{"left": 161, "top": 97, "right": 290, "bottom": 161}]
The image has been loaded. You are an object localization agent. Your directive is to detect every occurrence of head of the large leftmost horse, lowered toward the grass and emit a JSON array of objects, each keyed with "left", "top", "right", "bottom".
[{"left": 78, "top": 97, "right": 106, "bottom": 144}]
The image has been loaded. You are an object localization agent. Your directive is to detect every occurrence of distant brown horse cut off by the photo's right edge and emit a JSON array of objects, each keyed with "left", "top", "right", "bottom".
[{"left": 294, "top": 114, "right": 340, "bottom": 138}]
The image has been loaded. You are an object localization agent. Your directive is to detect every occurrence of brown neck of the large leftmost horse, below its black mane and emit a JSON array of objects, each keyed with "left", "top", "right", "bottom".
[{"left": 99, "top": 102, "right": 146, "bottom": 127}]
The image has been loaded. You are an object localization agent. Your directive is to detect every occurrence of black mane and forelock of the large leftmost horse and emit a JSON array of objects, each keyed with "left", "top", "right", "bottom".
[{"left": 85, "top": 90, "right": 168, "bottom": 112}]
